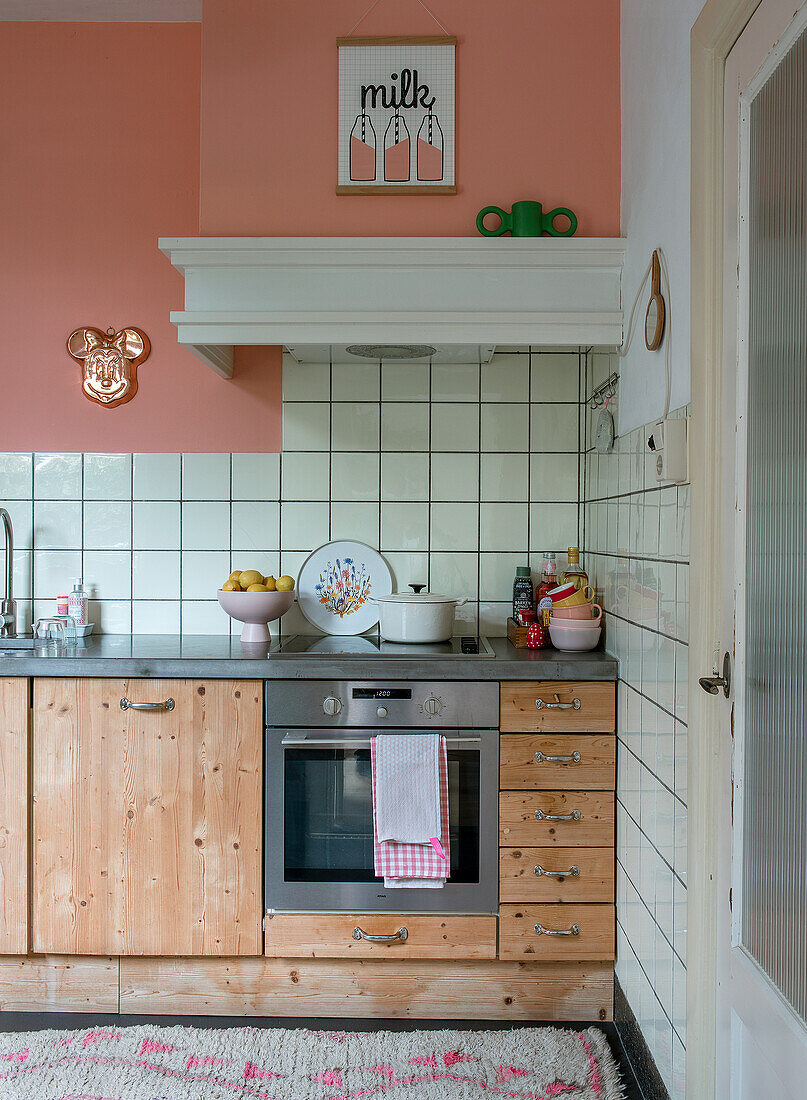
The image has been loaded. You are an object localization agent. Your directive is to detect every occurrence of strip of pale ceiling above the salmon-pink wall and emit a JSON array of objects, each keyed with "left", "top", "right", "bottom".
[{"left": 0, "top": 0, "right": 202, "bottom": 23}]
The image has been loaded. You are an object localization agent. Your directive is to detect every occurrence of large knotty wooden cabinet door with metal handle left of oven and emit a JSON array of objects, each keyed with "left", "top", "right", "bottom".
[{"left": 32, "top": 679, "right": 263, "bottom": 955}]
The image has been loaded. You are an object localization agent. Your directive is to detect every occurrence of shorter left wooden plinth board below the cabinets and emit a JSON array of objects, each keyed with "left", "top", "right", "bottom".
[{"left": 0, "top": 955, "right": 119, "bottom": 1012}]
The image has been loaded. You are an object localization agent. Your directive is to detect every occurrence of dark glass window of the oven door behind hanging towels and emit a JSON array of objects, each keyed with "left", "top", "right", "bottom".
[{"left": 284, "top": 748, "right": 479, "bottom": 882}]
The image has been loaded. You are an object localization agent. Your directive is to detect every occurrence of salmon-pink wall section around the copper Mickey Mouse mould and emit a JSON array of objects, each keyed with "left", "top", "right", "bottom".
[{"left": 0, "top": 22, "right": 280, "bottom": 455}]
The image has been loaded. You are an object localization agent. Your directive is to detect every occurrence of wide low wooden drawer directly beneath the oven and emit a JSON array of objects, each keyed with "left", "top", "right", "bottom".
[{"left": 265, "top": 913, "right": 496, "bottom": 959}]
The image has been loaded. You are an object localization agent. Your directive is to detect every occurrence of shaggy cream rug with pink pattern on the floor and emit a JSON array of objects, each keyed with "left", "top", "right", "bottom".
[{"left": 0, "top": 1026, "right": 622, "bottom": 1100}]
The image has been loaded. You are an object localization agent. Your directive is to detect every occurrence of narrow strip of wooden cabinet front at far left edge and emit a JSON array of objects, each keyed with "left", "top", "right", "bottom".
[{"left": 0, "top": 677, "right": 31, "bottom": 955}]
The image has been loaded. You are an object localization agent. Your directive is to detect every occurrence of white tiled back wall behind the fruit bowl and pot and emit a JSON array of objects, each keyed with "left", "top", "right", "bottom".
[{"left": 0, "top": 350, "right": 589, "bottom": 635}]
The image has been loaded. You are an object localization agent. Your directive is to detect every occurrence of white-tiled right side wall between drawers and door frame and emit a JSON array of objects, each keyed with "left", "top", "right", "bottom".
[{"left": 583, "top": 354, "right": 689, "bottom": 1100}]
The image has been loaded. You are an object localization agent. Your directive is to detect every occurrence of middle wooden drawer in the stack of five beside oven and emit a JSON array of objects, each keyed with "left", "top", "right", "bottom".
[{"left": 499, "top": 791, "right": 613, "bottom": 848}]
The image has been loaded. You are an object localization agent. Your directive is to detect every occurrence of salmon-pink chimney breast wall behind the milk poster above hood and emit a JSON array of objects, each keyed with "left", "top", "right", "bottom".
[{"left": 200, "top": 0, "right": 620, "bottom": 237}]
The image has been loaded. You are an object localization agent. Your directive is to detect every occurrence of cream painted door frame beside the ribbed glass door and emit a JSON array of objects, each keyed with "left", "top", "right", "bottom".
[{"left": 686, "top": 0, "right": 799, "bottom": 1100}]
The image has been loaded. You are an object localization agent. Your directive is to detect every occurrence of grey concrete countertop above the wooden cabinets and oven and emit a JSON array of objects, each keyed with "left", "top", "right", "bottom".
[{"left": 0, "top": 634, "right": 618, "bottom": 680}]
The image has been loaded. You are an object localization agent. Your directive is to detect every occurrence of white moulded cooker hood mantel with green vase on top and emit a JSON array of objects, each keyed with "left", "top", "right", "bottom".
[{"left": 159, "top": 237, "right": 626, "bottom": 377}]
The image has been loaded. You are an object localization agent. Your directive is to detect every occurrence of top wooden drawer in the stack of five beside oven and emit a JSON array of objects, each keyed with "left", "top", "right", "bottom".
[{"left": 499, "top": 680, "right": 617, "bottom": 734}]
